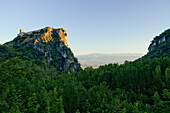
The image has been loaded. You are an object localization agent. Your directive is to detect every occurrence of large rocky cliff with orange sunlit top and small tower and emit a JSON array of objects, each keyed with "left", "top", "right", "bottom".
[{"left": 4, "top": 27, "right": 81, "bottom": 71}]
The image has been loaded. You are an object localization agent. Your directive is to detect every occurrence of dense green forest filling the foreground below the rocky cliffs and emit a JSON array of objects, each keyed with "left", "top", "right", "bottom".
[{"left": 0, "top": 58, "right": 170, "bottom": 113}]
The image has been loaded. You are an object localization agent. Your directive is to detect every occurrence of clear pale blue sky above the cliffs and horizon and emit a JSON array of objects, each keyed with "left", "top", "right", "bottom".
[{"left": 0, "top": 0, "right": 170, "bottom": 55}]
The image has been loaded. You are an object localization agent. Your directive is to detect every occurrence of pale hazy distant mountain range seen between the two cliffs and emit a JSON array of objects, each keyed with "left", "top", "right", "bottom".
[{"left": 77, "top": 53, "right": 144, "bottom": 68}]
